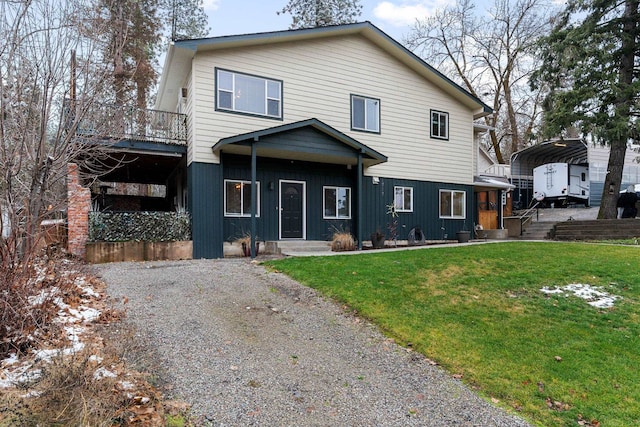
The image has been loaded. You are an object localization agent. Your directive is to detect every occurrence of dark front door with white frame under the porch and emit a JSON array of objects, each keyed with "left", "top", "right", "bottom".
[{"left": 280, "top": 181, "right": 305, "bottom": 239}]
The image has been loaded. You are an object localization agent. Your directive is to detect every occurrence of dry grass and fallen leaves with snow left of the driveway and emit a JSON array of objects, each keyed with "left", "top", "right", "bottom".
[{"left": 0, "top": 249, "right": 193, "bottom": 427}]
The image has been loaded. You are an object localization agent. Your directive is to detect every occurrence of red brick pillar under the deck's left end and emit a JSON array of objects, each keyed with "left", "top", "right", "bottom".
[{"left": 67, "top": 163, "right": 91, "bottom": 258}]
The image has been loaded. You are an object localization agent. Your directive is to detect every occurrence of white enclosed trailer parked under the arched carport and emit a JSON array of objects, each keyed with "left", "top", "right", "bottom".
[{"left": 533, "top": 163, "right": 589, "bottom": 207}]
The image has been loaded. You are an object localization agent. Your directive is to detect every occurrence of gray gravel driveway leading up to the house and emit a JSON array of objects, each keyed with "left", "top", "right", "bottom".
[{"left": 95, "top": 259, "right": 529, "bottom": 427}]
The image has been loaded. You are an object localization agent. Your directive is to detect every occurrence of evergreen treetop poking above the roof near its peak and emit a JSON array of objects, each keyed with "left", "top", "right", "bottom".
[{"left": 278, "top": 0, "right": 362, "bottom": 30}]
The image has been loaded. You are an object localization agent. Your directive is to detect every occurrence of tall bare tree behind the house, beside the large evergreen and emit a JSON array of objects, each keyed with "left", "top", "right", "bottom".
[{"left": 405, "top": 0, "right": 552, "bottom": 163}]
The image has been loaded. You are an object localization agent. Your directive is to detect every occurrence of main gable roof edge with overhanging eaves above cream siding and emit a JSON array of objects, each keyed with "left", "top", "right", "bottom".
[{"left": 156, "top": 21, "right": 493, "bottom": 118}]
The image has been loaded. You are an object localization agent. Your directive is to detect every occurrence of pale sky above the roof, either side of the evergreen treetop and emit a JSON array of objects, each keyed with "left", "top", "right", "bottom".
[{"left": 204, "top": 0, "right": 454, "bottom": 41}]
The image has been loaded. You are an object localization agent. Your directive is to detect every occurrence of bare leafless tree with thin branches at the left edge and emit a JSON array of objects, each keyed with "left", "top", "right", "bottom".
[{"left": 0, "top": 0, "right": 116, "bottom": 270}]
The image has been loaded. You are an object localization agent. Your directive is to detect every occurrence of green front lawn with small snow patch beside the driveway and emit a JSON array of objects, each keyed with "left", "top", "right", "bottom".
[{"left": 265, "top": 242, "right": 640, "bottom": 427}]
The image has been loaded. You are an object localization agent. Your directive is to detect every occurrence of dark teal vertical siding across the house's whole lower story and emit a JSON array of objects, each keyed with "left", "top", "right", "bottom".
[{"left": 188, "top": 155, "right": 474, "bottom": 258}]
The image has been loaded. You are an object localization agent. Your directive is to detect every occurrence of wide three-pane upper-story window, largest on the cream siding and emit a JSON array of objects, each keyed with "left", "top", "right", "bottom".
[{"left": 216, "top": 68, "right": 282, "bottom": 119}]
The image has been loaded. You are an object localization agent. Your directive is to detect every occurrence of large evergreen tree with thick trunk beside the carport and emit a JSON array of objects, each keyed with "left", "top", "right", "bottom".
[{"left": 532, "top": 0, "right": 640, "bottom": 218}]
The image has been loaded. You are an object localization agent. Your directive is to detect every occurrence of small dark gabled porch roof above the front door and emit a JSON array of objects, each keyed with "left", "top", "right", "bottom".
[{"left": 212, "top": 119, "right": 387, "bottom": 166}]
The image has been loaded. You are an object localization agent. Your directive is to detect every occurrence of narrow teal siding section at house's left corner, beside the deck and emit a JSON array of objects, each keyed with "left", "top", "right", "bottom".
[{"left": 187, "top": 162, "right": 223, "bottom": 258}]
